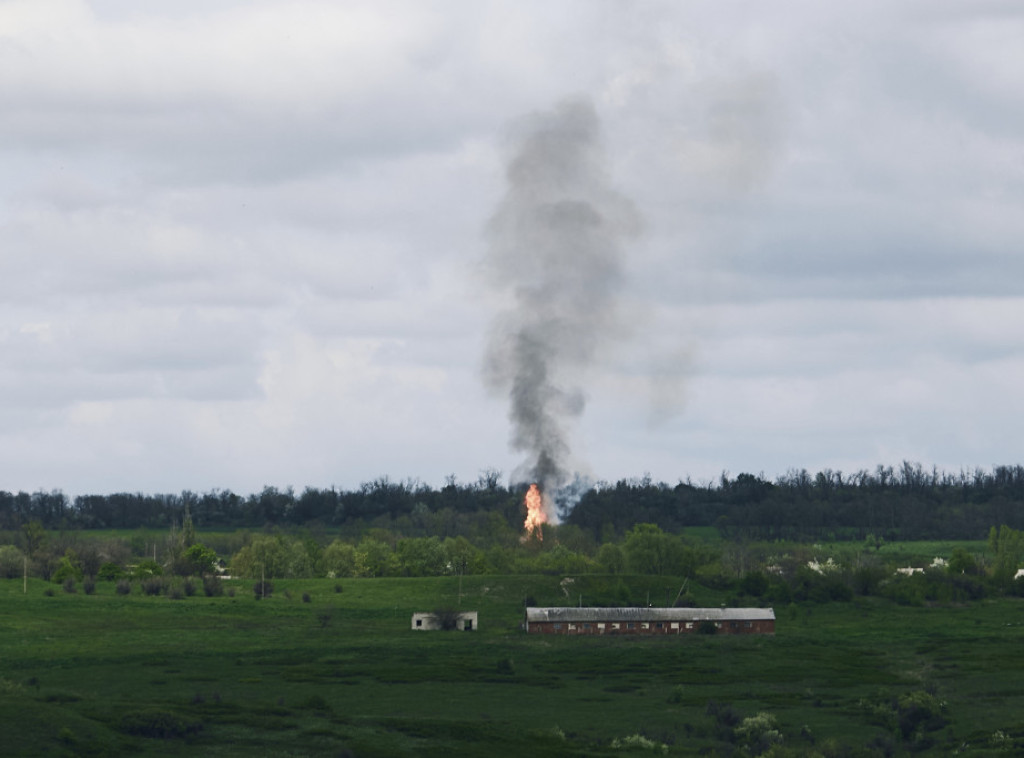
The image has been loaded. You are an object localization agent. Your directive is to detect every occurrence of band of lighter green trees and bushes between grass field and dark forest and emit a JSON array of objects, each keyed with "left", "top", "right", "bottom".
[{"left": 6, "top": 515, "right": 1024, "bottom": 604}]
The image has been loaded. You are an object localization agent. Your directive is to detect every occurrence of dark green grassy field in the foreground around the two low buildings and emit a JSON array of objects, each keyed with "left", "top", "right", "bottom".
[{"left": 0, "top": 576, "right": 1024, "bottom": 756}]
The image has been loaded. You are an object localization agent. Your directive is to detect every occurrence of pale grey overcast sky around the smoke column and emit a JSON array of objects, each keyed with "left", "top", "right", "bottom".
[{"left": 0, "top": 0, "right": 1024, "bottom": 495}]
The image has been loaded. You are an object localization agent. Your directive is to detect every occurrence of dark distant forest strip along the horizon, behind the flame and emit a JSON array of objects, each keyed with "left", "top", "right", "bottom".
[{"left": 6, "top": 462, "right": 1024, "bottom": 542}]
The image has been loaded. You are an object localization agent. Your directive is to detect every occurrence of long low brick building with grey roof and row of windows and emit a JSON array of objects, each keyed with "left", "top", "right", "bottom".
[{"left": 523, "top": 607, "right": 775, "bottom": 635}]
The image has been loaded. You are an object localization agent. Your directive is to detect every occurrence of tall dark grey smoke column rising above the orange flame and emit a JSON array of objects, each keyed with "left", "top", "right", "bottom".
[{"left": 484, "top": 100, "right": 639, "bottom": 516}]
